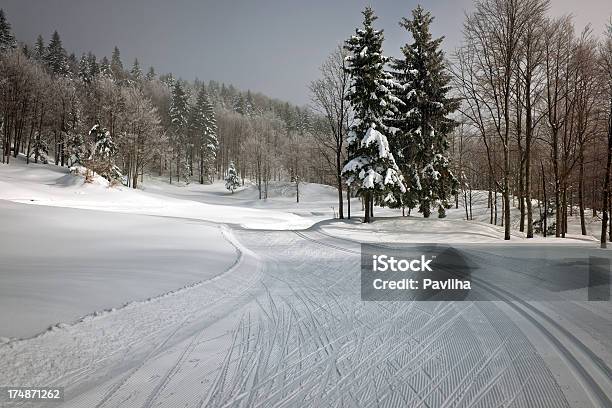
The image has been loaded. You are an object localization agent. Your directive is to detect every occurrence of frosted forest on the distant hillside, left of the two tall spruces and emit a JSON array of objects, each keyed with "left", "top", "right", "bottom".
[{"left": 0, "top": 11, "right": 340, "bottom": 195}]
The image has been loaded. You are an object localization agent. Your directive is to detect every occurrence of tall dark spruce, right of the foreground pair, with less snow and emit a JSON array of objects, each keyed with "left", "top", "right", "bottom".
[{"left": 391, "top": 6, "right": 458, "bottom": 218}]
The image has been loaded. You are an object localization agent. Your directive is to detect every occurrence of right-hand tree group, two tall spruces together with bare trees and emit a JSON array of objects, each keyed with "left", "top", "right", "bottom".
[{"left": 310, "top": 0, "right": 612, "bottom": 245}]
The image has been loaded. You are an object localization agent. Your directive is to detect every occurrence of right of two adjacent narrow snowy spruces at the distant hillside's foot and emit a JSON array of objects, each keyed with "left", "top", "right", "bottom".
[{"left": 189, "top": 86, "right": 219, "bottom": 184}]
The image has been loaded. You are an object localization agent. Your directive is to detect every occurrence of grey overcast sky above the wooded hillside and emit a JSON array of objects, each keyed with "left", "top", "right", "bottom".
[{"left": 0, "top": 0, "right": 612, "bottom": 105}]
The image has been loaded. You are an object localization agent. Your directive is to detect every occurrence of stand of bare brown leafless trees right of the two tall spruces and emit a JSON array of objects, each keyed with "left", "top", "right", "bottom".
[{"left": 451, "top": 0, "right": 612, "bottom": 245}]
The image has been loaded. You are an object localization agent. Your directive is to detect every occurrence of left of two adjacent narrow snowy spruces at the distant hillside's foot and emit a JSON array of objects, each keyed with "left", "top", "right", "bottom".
[{"left": 170, "top": 81, "right": 189, "bottom": 182}]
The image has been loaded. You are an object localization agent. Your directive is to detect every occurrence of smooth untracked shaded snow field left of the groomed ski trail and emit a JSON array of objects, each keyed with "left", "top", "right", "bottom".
[{"left": 0, "top": 201, "right": 237, "bottom": 337}]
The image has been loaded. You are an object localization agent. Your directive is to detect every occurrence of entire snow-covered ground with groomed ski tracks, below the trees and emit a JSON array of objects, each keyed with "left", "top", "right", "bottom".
[{"left": 0, "top": 157, "right": 612, "bottom": 408}]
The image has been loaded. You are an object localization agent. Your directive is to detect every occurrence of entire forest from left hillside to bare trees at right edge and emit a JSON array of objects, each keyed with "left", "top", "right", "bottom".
[{"left": 0, "top": 0, "right": 612, "bottom": 242}]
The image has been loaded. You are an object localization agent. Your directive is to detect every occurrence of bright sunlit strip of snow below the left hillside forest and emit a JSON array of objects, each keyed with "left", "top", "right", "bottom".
[{"left": 0, "top": 159, "right": 313, "bottom": 229}]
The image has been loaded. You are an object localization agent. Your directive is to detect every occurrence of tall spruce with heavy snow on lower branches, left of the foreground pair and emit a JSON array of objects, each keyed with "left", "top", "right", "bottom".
[{"left": 342, "top": 7, "right": 406, "bottom": 222}]
